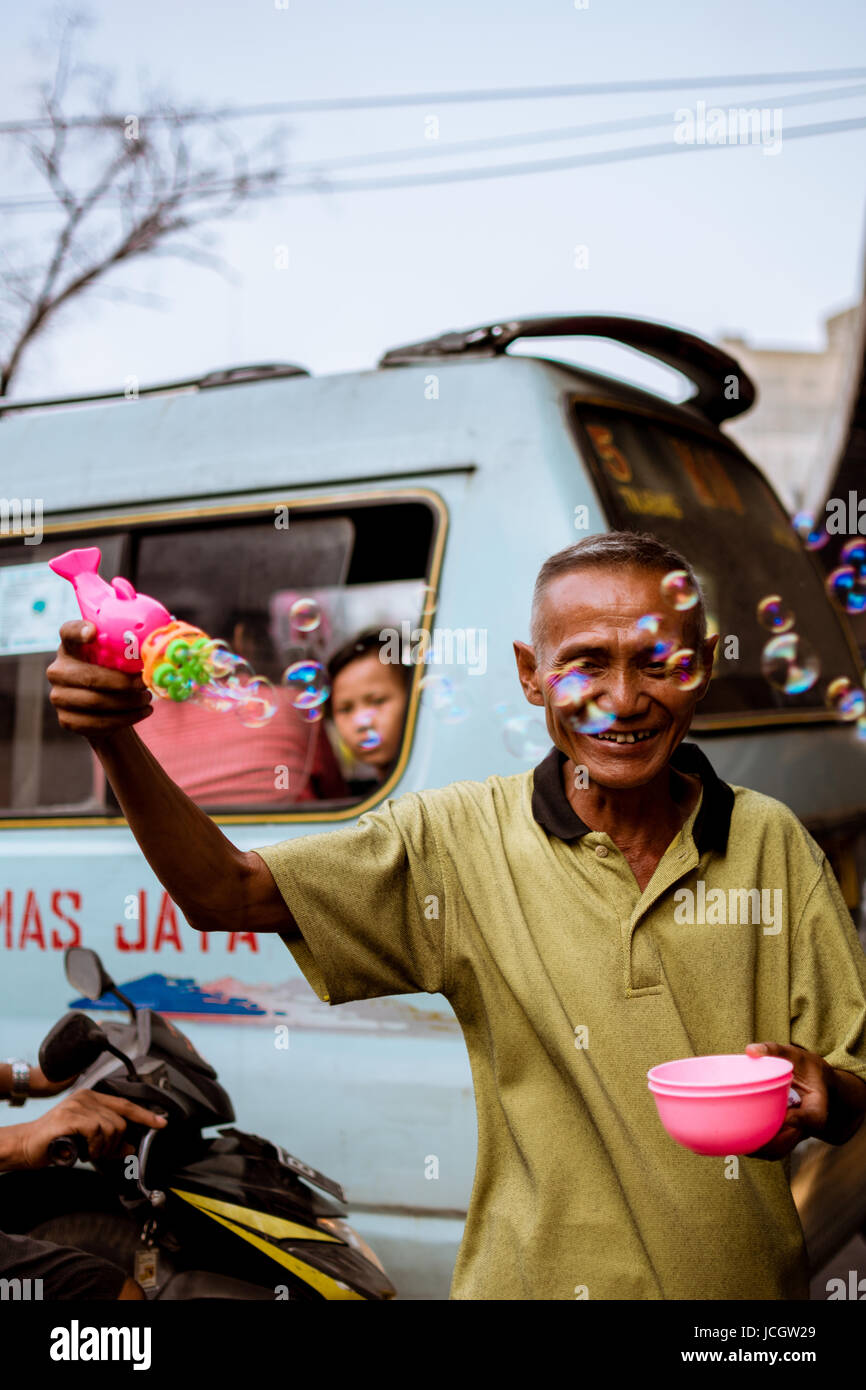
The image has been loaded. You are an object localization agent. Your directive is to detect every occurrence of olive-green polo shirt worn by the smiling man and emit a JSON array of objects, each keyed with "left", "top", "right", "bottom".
[{"left": 257, "top": 744, "right": 866, "bottom": 1300}]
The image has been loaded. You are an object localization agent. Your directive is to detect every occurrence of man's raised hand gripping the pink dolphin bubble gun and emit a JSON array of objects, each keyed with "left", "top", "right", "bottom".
[{"left": 46, "top": 619, "right": 153, "bottom": 738}]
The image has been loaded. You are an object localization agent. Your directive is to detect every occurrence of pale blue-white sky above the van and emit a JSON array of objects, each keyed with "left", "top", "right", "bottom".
[{"left": 0, "top": 0, "right": 866, "bottom": 399}]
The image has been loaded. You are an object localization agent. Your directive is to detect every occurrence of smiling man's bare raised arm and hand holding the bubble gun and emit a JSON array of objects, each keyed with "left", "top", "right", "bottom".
[{"left": 46, "top": 620, "right": 297, "bottom": 937}]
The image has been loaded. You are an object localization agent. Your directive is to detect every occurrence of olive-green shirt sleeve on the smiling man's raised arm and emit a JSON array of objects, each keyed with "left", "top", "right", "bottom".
[{"left": 256, "top": 792, "right": 445, "bottom": 1004}]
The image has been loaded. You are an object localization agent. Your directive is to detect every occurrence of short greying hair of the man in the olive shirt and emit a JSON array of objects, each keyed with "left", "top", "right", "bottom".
[{"left": 530, "top": 531, "right": 706, "bottom": 652}]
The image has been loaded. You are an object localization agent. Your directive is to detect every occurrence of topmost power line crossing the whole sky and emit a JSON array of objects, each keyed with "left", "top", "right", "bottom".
[{"left": 0, "top": 68, "right": 866, "bottom": 135}]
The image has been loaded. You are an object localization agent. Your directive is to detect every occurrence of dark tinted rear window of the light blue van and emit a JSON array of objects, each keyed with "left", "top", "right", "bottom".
[{"left": 577, "top": 409, "right": 860, "bottom": 727}]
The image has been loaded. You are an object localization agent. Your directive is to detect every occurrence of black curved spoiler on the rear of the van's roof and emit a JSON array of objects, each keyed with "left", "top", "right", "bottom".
[{"left": 379, "top": 314, "right": 756, "bottom": 424}]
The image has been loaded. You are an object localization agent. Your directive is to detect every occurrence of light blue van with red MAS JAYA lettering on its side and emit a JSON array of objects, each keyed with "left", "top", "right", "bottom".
[{"left": 0, "top": 317, "right": 866, "bottom": 1298}]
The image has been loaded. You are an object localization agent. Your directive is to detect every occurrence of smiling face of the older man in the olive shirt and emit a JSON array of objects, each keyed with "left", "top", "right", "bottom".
[{"left": 514, "top": 567, "right": 719, "bottom": 790}]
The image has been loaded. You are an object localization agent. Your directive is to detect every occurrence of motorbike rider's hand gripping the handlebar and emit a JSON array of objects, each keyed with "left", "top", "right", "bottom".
[{"left": 8, "top": 1091, "right": 167, "bottom": 1168}]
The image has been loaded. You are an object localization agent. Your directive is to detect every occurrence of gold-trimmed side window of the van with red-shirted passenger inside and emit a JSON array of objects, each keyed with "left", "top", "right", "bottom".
[{"left": 0, "top": 498, "right": 436, "bottom": 816}]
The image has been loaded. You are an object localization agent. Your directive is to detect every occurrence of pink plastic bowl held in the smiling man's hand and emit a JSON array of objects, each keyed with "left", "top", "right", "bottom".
[{"left": 646, "top": 1052, "right": 794, "bottom": 1154}]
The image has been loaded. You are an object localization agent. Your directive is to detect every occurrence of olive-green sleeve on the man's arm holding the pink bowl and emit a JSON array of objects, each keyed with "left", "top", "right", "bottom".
[{"left": 791, "top": 858, "right": 866, "bottom": 1079}]
